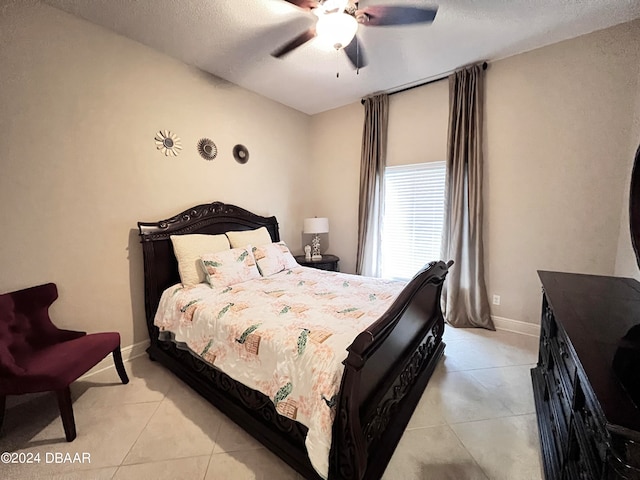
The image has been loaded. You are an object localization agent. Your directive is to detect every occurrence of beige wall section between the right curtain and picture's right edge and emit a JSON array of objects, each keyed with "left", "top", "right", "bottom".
[{"left": 485, "top": 22, "right": 640, "bottom": 323}]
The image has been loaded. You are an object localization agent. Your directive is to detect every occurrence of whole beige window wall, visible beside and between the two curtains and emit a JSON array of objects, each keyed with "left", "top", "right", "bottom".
[{"left": 312, "top": 21, "right": 640, "bottom": 323}]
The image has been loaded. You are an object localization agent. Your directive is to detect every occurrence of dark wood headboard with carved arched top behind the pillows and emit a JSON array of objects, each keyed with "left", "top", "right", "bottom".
[{"left": 138, "top": 202, "right": 280, "bottom": 342}]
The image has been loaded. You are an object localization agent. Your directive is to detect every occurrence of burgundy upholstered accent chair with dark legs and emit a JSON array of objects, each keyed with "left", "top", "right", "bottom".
[{"left": 0, "top": 283, "right": 129, "bottom": 442}]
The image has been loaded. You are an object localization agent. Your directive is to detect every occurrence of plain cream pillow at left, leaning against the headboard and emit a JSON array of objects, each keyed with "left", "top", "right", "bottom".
[{"left": 170, "top": 234, "right": 231, "bottom": 286}]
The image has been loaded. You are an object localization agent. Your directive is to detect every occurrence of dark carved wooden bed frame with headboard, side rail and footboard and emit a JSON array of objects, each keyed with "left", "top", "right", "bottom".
[{"left": 138, "top": 202, "right": 452, "bottom": 480}]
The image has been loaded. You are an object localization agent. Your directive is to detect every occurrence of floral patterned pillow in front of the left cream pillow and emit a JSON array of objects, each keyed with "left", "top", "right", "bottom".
[{"left": 200, "top": 247, "right": 260, "bottom": 288}]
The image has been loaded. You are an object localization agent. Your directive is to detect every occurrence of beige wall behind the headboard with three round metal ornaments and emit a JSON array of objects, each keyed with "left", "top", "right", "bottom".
[{"left": 0, "top": 2, "right": 310, "bottom": 346}]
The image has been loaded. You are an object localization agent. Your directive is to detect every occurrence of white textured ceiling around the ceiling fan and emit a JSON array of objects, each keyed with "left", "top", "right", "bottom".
[{"left": 43, "top": 0, "right": 640, "bottom": 114}]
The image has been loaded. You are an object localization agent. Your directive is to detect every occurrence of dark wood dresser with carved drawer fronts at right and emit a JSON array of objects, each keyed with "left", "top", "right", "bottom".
[{"left": 531, "top": 271, "right": 640, "bottom": 480}]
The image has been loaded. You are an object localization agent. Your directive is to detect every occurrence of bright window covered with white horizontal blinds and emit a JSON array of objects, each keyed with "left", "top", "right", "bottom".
[{"left": 381, "top": 162, "right": 446, "bottom": 280}]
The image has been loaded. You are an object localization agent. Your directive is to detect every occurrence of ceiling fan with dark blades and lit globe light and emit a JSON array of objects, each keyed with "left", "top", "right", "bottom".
[{"left": 271, "top": 0, "right": 438, "bottom": 69}]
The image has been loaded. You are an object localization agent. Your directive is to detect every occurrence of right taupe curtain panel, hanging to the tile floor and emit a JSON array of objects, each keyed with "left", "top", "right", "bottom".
[{"left": 442, "top": 65, "right": 495, "bottom": 330}]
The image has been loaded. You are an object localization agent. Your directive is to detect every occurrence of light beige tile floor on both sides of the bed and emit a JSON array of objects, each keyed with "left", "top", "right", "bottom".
[{"left": 0, "top": 327, "right": 542, "bottom": 480}]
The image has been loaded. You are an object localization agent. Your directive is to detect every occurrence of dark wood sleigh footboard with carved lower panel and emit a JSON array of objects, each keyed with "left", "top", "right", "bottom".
[{"left": 329, "top": 262, "right": 452, "bottom": 479}]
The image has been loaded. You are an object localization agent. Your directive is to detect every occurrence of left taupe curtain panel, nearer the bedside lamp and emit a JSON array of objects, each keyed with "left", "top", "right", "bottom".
[{"left": 356, "top": 94, "right": 389, "bottom": 277}]
